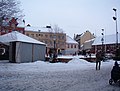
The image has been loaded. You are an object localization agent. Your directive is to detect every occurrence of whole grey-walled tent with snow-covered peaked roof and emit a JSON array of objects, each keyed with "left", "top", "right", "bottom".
[{"left": 0, "top": 31, "right": 46, "bottom": 62}]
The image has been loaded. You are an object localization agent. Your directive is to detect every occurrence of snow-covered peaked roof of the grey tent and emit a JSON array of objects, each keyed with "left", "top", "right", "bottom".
[{"left": 0, "top": 31, "right": 45, "bottom": 45}]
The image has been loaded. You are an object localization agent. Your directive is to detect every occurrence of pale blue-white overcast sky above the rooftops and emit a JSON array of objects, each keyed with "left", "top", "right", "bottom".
[{"left": 20, "top": 0, "right": 120, "bottom": 37}]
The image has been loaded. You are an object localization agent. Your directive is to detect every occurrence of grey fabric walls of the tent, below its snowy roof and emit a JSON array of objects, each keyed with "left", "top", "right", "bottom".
[{"left": 9, "top": 42, "right": 46, "bottom": 63}]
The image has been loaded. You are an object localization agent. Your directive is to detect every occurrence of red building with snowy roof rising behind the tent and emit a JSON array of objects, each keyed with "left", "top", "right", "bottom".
[{"left": 0, "top": 18, "right": 25, "bottom": 35}]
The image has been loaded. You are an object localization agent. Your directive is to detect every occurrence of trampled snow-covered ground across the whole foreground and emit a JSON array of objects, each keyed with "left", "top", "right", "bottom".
[{"left": 0, "top": 56, "right": 120, "bottom": 91}]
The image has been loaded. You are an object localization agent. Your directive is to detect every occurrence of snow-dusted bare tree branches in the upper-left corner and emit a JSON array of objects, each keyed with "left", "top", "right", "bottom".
[{"left": 0, "top": 0, "right": 23, "bottom": 22}]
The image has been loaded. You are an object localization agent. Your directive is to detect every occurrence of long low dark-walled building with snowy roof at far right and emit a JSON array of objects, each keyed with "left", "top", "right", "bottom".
[{"left": 91, "top": 34, "right": 120, "bottom": 53}]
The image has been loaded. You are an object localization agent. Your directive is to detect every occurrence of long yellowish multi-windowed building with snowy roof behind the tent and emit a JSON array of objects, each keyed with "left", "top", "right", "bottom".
[{"left": 25, "top": 26, "right": 66, "bottom": 54}]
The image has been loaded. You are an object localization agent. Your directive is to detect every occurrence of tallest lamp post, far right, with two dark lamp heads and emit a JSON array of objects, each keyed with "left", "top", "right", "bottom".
[{"left": 113, "top": 8, "right": 118, "bottom": 57}]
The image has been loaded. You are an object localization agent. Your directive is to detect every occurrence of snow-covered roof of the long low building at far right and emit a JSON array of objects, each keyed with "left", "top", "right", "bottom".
[{"left": 93, "top": 33, "right": 120, "bottom": 45}]
